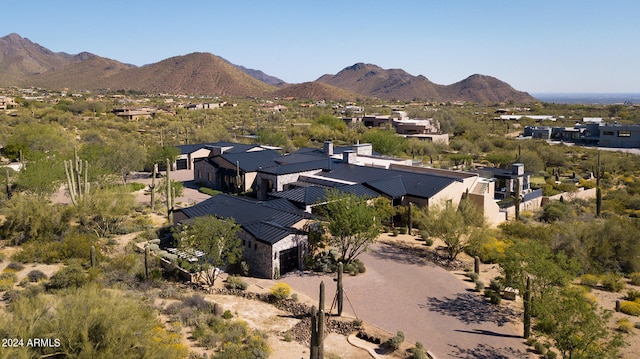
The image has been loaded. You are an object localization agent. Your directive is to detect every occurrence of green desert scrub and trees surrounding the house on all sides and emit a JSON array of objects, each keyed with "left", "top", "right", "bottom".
[{"left": 0, "top": 88, "right": 640, "bottom": 358}]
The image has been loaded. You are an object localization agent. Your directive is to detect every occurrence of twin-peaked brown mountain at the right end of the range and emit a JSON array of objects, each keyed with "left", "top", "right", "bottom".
[{"left": 316, "top": 63, "right": 536, "bottom": 103}]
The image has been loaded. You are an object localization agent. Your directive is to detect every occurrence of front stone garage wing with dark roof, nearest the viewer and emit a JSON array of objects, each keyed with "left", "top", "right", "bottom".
[{"left": 174, "top": 194, "right": 309, "bottom": 278}]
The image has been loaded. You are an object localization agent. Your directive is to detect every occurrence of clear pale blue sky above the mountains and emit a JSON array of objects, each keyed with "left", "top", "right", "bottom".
[{"left": 0, "top": 0, "right": 640, "bottom": 93}]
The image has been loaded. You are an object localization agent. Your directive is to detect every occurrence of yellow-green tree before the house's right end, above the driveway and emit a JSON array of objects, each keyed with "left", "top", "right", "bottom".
[{"left": 416, "top": 199, "right": 486, "bottom": 261}]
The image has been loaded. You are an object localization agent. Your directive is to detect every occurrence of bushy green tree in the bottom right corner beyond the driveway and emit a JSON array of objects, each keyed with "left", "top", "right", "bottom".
[{"left": 536, "top": 287, "right": 624, "bottom": 359}]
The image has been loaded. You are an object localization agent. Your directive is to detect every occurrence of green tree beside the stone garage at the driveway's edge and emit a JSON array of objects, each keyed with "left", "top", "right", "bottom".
[{"left": 320, "top": 190, "right": 382, "bottom": 264}]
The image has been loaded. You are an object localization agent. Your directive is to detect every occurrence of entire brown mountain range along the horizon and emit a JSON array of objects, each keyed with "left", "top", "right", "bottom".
[{"left": 0, "top": 33, "right": 537, "bottom": 103}]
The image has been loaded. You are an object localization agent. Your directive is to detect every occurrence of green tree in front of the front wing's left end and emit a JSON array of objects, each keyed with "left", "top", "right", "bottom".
[{"left": 174, "top": 215, "right": 244, "bottom": 285}]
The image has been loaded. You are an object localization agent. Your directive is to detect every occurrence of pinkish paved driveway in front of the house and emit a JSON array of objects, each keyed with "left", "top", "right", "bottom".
[{"left": 282, "top": 244, "right": 536, "bottom": 359}]
